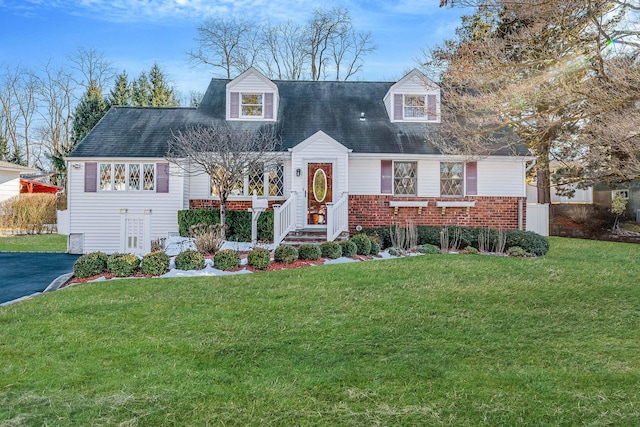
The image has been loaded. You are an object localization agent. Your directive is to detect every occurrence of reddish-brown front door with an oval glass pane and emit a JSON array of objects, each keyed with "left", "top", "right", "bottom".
[{"left": 307, "top": 163, "right": 333, "bottom": 225}]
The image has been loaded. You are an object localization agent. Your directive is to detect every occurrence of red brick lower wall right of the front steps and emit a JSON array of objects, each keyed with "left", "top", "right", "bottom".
[{"left": 349, "top": 196, "right": 527, "bottom": 233}]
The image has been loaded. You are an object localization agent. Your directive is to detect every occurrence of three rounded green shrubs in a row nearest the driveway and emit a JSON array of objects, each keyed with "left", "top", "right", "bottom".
[{"left": 73, "top": 251, "right": 169, "bottom": 279}]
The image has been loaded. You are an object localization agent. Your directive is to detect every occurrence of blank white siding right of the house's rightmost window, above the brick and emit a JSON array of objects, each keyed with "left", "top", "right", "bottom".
[{"left": 478, "top": 158, "right": 526, "bottom": 197}]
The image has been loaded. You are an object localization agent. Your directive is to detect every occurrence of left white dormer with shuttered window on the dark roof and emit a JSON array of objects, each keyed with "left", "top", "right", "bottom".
[{"left": 227, "top": 67, "right": 278, "bottom": 121}]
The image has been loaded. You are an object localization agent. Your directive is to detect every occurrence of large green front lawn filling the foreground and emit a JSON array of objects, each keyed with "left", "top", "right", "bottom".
[{"left": 0, "top": 238, "right": 640, "bottom": 426}]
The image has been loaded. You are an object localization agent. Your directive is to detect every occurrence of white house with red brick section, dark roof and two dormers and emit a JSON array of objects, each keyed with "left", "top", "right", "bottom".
[{"left": 67, "top": 68, "right": 534, "bottom": 253}]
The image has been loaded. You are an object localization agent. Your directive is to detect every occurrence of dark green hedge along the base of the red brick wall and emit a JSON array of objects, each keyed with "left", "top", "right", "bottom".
[{"left": 363, "top": 225, "right": 549, "bottom": 256}]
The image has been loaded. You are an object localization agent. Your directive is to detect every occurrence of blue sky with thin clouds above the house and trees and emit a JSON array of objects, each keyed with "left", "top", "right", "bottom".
[{"left": 0, "top": 0, "right": 468, "bottom": 100}]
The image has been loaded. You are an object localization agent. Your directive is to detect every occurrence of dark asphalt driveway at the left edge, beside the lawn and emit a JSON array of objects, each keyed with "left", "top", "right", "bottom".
[{"left": 0, "top": 252, "right": 78, "bottom": 304}]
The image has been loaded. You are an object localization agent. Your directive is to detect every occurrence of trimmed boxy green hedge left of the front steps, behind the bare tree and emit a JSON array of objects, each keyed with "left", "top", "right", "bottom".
[{"left": 178, "top": 209, "right": 273, "bottom": 242}]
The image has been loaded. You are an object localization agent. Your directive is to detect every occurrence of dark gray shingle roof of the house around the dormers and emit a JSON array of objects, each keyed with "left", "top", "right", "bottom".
[{"left": 68, "top": 79, "right": 526, "bottom": 158}]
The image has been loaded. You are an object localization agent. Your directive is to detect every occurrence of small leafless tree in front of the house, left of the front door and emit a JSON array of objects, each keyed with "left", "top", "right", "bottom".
[{"left": 167, "top": 125, "right": 280, "bottom": 238}]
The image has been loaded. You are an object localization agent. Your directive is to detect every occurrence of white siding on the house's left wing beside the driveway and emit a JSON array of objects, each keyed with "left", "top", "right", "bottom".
[{"left": 68, "top": 159, "right": 184, "bottom": 253}]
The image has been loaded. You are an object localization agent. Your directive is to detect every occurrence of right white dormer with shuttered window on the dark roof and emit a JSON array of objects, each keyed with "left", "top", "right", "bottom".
[{"left": 384, "top": 69, "right": 440, "bottom": 123}]
